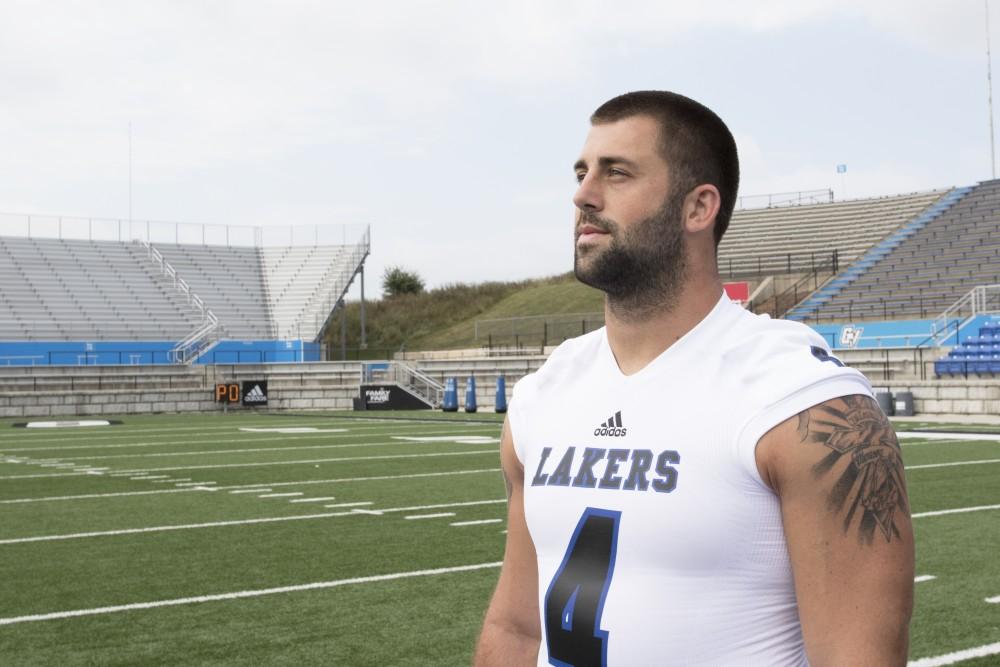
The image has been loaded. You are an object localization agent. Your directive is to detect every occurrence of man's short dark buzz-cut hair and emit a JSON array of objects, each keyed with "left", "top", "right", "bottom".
[{"left": 590, "top": 90, "right": 740, "bottom": 245}]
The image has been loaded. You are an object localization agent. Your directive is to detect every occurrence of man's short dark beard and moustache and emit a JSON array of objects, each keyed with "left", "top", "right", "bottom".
[{"left": 573, "top": 192, "right": 687, "bottom": 320}]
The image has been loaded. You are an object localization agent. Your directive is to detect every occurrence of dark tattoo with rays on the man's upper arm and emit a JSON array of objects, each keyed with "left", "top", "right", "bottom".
[{"left": 798, "top": 396, "right": 909, "bottom": 544}]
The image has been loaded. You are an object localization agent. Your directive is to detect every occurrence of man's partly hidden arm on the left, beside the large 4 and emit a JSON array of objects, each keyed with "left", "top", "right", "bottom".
[{"left": 475, "top": 422, "right": 541, "bottom": 667}]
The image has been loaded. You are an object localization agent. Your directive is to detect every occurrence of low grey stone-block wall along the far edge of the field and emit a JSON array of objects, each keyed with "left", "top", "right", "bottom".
[{"left": 0, "top": 355, "right": 1000, "bottom": 417}]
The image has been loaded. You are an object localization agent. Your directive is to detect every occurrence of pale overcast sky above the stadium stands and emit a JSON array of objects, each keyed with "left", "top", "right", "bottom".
[{"left": 0, "top": 0, "right": 1000, "bottom": 293}]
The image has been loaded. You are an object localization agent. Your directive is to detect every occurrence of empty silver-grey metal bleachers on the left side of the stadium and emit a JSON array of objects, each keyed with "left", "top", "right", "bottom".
[{"left": 0, "top": 222, "right": 369, "bottom": 363}]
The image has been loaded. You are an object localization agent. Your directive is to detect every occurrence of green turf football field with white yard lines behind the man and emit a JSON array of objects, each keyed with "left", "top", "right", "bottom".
[{"left": 0, "top": 413, "right": 1000, "bottom": 667}]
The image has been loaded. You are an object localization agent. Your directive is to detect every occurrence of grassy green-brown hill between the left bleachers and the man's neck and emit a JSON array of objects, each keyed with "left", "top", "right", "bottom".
[{"left": 327, "top": 273, "right": 604, "bottom": 357}]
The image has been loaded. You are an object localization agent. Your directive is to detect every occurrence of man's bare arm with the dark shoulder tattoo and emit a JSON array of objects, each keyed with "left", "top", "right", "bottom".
[{"left": 757, "top": 396, "right": 913, "bottom": 667}]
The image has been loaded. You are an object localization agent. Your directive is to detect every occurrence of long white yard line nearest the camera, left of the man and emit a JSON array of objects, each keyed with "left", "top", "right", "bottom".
[{"left": 0, "top": 562, "right": 501, "bottom": 625}]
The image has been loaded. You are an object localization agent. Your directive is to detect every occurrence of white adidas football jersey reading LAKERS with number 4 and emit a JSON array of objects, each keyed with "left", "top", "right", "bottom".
[{"left": 509, "top": 296, "right": 871, "bottom": 667}]
